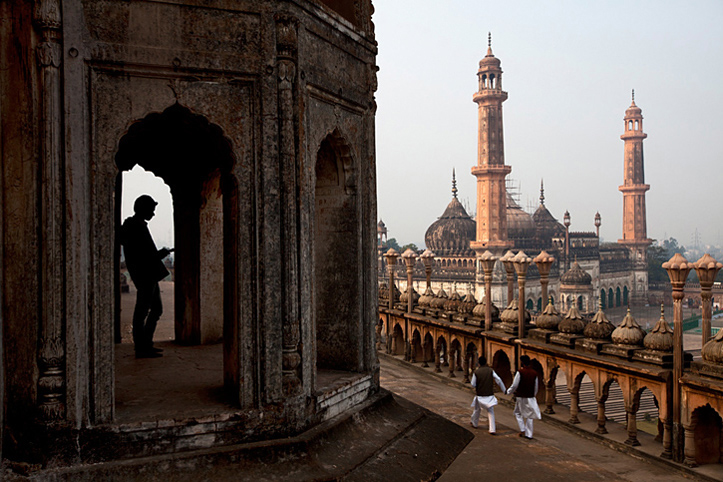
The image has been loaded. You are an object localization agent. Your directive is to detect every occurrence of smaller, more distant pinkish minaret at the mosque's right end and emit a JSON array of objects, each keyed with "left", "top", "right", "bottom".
[{"left": 618, "top": 90, "right": 652, "bottom": 304}]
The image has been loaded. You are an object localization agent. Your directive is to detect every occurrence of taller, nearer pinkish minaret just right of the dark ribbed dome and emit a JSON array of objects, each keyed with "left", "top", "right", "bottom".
[{"left": 470, "top": 35, "right": 512, "bottom": 255}]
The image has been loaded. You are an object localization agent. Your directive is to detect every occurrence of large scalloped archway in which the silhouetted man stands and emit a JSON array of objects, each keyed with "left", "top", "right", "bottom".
[{"left": 114, "top": 104, "right": 240, "bottom": 422}]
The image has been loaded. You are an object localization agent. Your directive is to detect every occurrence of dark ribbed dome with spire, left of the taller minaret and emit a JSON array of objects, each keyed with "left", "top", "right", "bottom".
[{"left": 424, "top": 174, "right": 477, "bottom": 257}]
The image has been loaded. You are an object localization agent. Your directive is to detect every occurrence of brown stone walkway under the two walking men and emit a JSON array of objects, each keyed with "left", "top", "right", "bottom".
[{"left": 379, "top": 353, "right": 698, "bottom": 482}]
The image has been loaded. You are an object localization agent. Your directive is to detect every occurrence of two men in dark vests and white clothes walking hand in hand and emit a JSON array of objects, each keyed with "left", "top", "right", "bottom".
[{"left": 470, "top": 355, "right": 542, "bottom": 439}]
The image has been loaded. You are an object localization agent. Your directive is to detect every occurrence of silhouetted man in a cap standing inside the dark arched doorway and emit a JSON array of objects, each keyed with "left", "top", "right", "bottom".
[{"left": 121, "top": 194, "right": 172, "bottom": 358}]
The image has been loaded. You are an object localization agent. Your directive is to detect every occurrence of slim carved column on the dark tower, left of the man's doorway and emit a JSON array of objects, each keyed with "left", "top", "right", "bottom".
[{"left": 33, "top": 0, "right": 65, "bottom": 423}]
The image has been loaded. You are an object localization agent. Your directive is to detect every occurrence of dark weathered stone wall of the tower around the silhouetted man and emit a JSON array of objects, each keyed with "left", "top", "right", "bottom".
[{"left": 0, "top": 0, "right": 378, "bottom": 466}]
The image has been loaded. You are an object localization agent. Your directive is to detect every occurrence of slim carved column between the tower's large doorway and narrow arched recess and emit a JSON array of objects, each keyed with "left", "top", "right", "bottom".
[{"left": 276, "top": 16, "right": 301, "bottom": 395}]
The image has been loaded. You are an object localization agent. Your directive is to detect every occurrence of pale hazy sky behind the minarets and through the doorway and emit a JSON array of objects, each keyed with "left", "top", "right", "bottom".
[{"left": 123, "top": 0, "right": 723, "bottom": 252}]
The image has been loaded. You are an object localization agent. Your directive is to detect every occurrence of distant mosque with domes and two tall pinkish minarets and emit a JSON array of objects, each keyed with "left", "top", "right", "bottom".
[{"left": 388, "top": 38, "right": 651, "bottom": 313}]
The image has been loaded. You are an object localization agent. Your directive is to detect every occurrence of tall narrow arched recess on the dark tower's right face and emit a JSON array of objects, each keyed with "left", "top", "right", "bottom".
[{"left": 313, "top": 130, "right": 362, "bottom": 371}]
